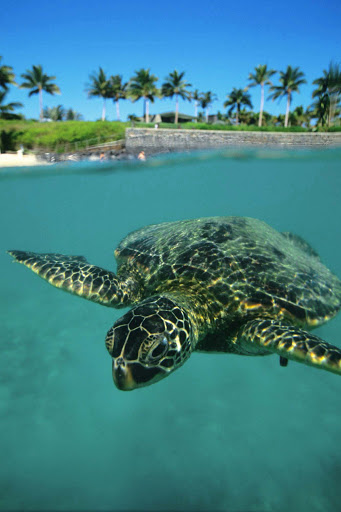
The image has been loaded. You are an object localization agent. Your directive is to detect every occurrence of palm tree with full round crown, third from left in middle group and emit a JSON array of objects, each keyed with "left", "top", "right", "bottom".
[{"left": 128, "top": 68, "right": 159, "bottom": 123}]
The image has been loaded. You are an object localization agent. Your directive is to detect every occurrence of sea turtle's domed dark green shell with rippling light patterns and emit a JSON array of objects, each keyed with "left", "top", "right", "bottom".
[{"left": 115, "top": 217, "right": 341, "bottom": 327}]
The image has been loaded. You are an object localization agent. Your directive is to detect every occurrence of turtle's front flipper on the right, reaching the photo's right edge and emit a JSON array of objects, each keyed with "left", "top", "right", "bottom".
[{"left": 234, "top": 319, "right": 341, "bottom": 375}]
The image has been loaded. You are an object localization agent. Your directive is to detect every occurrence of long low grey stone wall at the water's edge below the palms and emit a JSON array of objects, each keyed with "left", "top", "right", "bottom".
[{"left": 126, "top": 128, "right": 341, "bottom": 154}]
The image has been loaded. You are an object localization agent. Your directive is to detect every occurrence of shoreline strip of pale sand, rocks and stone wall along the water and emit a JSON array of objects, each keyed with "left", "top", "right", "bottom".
[{"left": 0, "top": 128, "right": 341, "bottom": 170}]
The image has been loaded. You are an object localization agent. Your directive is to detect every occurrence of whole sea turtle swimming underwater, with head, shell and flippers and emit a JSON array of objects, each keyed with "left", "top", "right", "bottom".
[{"left": 9, "top": 217, "right": 341, "bottom": 390}]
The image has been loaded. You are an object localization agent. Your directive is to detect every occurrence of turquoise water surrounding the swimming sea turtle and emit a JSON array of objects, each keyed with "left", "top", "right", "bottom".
[{"left": 0, "top": 150, "right": 341, "bottom": 512}]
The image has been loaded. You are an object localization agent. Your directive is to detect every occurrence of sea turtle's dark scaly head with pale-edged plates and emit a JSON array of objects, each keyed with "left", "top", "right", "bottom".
[{"left": 105, "top": 296, "right": 192, "bottom": 391}]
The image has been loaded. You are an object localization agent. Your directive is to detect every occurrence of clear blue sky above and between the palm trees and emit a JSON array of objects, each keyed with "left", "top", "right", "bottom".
[{"left": 0, "top": 0, "right": 341, "bottom": 120}]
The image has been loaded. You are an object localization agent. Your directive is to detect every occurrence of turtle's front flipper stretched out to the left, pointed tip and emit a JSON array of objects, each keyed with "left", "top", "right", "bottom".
[{"left": 8, "top": 251, "right": 130, "bottom": 307}]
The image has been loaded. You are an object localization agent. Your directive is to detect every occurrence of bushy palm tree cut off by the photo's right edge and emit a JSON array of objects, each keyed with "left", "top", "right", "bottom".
[{"left": 312, "top": 62, "right": 341, "bottom": 126}]
